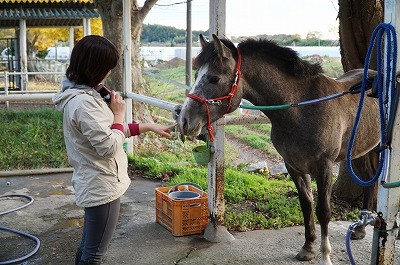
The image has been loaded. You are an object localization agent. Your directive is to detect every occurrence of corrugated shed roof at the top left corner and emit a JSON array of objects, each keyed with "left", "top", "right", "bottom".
[{"left": 0, "top": 0, "right": 100, "bottom": 28}]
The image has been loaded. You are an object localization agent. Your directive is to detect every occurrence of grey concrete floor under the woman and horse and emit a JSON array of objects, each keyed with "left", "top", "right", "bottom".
[{"left": 0, "top": 173, "right": 399, "bottom": 265}]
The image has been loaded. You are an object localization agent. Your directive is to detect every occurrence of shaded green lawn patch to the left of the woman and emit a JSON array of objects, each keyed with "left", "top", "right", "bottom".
[{"left": 0, "top": 108, "right": 68, "bottom": 170}]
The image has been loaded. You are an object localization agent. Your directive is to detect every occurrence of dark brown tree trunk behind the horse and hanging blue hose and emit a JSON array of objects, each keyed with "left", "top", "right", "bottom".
[{"left": 332, "top": 0, "right": 384, "bottom": 204}]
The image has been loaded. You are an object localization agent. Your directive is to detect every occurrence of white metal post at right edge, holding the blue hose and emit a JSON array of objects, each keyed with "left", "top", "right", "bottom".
[{"left": 371, "top": 0, "right": 400, "bottom": 264}]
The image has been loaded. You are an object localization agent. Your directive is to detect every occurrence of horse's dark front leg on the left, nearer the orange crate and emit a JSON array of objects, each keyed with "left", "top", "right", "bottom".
[{"left": 286, "top": 164, "right": 316, "bottom": 261}]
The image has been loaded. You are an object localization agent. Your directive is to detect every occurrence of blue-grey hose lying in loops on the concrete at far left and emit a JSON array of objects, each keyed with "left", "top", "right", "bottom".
[{"left": 0, "top": 194, "right": 40, "bottom": 265}]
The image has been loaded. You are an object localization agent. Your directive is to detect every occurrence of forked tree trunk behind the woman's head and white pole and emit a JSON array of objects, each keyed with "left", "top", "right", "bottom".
[{"left": 94, "top": 0, "right": 157, "bottom": 122}]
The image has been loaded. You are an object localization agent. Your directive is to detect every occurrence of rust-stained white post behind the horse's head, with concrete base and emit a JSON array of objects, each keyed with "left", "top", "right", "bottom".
[{"left": 204, "top": 0, "right": 234, "bottom": 242}]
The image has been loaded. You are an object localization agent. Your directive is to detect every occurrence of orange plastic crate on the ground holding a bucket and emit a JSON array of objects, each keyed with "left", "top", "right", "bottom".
[{"left": 156, "top": 186, "right": 209, "bottom": 236}]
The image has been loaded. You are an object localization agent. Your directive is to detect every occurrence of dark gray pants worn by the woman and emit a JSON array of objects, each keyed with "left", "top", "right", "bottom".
[{"left": 75, "top": 199, "right": 120, "bottom": 264}]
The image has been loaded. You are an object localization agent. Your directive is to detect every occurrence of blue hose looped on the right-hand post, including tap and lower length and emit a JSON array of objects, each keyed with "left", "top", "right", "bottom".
[{"left": 346, "top": 23, "right": 400, "bottom": 265}]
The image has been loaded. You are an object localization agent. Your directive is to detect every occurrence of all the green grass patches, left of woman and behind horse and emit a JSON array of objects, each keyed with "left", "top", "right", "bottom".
[{"left": 0, "top": 57, "right": 358, "bottom": 231}]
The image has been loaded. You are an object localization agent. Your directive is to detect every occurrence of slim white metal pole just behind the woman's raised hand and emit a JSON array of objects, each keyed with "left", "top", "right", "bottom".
[{"left": 122, "top": 0, "right": 133, "bottom": 154}]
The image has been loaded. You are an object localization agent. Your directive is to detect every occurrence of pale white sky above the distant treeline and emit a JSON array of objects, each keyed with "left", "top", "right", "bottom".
[{"left": 138, "top": 0, "right": 339, "bottom": 39}]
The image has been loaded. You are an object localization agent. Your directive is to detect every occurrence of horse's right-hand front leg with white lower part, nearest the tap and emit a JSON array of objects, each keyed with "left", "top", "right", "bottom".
[{"left": 315, "top": 162, "right": 332, "bottom": 265}]
